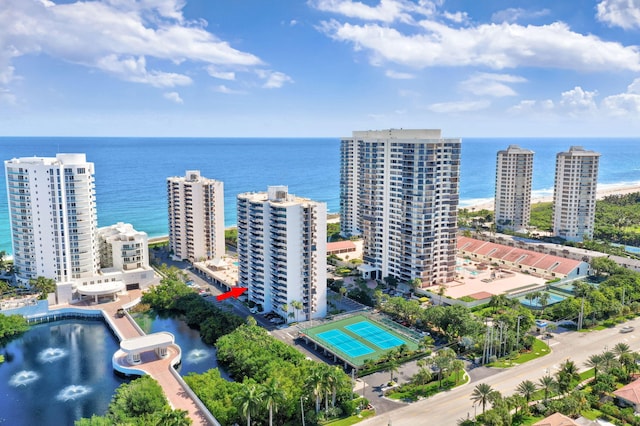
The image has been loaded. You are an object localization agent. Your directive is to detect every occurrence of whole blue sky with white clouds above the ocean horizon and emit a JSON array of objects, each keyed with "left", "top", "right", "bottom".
[{"left": 0, "top": 0, "right": 640, "bottom": 137}]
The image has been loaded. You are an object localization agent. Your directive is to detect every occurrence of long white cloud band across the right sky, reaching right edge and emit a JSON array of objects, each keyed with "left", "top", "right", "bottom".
[{"left": 320, "top": 20, "right": 640, "bottom": 71}]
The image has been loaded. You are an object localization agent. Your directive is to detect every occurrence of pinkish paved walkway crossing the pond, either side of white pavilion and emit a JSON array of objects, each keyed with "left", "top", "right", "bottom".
[{"left": 51, "top": 290, "right": 213, "bottom": 425}]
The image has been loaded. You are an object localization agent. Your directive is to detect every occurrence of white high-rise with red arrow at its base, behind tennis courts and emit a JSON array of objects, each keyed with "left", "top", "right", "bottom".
[{"left": 238, "top": 186, "right": 327, "bottom": 321}]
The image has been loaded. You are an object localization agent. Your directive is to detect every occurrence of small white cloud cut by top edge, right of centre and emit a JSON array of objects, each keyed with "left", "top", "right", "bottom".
[{"left": 309, "top": 0, "right": 435, "bottom": 23}]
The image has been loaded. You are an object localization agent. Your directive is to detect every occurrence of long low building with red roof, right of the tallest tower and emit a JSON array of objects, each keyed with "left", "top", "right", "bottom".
[{"left": 458, "top": 236, "right": 589, "bottom": 279}]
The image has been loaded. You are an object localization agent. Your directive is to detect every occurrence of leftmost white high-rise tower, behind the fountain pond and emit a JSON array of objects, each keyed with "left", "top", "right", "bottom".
[{"left": 5, "top": 154, "right": 99, "bottom": 283}]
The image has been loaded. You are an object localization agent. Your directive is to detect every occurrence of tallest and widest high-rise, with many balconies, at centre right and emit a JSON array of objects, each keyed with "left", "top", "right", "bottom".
[{"left": 340, "top": 129, "right": 461, "bottom": 286}]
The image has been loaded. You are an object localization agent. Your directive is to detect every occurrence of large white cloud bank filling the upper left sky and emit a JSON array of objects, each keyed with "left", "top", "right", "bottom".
[{"left": 0, "top": 0, "right": 272, "bottom": 96}]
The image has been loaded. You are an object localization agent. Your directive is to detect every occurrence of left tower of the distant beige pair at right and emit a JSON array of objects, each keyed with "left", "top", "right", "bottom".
[{"left": 494, "top": 145, "right": 534, "bottom": 231}]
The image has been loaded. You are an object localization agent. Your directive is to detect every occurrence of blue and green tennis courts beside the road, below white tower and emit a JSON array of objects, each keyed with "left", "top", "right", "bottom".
[{"left": 302, "top": 315, "right": 418, "bottom": 366}]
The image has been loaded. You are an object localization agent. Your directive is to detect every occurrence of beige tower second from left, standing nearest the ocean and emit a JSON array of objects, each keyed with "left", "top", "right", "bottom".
[{"left": 167, "top": 170, "right": 225, "bottom": 262}]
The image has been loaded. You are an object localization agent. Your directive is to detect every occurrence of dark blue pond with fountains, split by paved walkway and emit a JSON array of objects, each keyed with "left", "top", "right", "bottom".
[{"left": 0, "top": 312, "right": 226, "bottom": 426}]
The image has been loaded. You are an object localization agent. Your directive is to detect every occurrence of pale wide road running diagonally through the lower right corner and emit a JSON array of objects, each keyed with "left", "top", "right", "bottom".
[{"left": 358, "top": 319, "right": 640, "bottom": 426}]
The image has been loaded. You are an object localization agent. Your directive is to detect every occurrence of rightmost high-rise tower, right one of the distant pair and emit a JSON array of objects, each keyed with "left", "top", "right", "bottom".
[{"left": 553, "top": 146, "right": 600, "bottom": 242}]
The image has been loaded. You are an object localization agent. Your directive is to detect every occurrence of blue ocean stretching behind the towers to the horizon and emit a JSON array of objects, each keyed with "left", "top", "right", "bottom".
[{"left": 0, "top": 135, "right": 640, "bottom": 253}]
